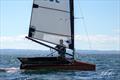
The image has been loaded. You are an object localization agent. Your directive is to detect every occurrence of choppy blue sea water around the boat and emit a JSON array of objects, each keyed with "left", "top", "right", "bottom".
[{"left": 0, "top": 50, "right": 120, "bottom": 80}]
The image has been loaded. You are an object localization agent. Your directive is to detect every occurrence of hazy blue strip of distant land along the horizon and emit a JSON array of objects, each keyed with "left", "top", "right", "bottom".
[{"left": 0, "top": 49, "right": 120, "bottom": 54}]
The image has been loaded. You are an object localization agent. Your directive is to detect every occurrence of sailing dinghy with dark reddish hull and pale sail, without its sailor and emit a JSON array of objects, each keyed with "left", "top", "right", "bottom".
[{"left": 18, "top": 0, "right": 96, "bottom": 71}]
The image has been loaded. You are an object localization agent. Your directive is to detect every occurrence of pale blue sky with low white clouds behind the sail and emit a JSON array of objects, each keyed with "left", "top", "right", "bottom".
[{"left": 0, "top": 0, "right": 120, "bottom": 50}]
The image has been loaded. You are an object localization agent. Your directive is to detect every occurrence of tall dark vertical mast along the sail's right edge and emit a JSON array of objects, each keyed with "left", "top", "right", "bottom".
[{"left": 70, "top": 0, "right": 75, "bottom": 59}]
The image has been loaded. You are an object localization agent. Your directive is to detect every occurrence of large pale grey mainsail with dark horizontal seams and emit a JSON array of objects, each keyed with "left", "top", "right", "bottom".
[{"left": 28, "top": 0, "right": 74, "bottom": 49}]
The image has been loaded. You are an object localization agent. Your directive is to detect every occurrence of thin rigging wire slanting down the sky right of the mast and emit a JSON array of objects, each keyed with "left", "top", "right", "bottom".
[{"left": 78, "top": 0, "right": 92, "bottom": 49}]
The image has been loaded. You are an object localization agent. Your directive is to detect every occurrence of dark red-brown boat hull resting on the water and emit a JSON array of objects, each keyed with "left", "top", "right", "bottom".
[{"left": 18, "top": 58, "right": 96, "bottom": 71}]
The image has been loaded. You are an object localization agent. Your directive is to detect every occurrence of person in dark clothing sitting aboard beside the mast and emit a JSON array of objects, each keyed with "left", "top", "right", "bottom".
[{"left": 55, "top": 39, "right": 66, "bottom": 59}]
